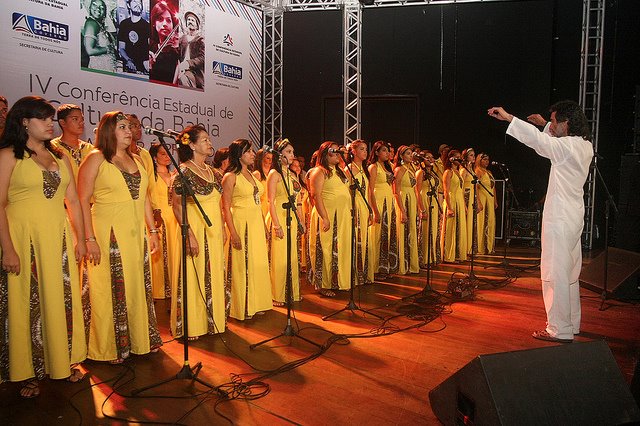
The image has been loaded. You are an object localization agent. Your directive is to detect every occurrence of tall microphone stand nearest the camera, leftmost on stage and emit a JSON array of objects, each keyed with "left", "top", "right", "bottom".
[{"left": 131, "top": 135, "right": 228, "bottom": 397}]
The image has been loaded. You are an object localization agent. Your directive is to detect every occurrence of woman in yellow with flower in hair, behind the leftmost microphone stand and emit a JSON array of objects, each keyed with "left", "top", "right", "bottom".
[{"left": 171, "top": 126, "right": 228, "bottom": 340}]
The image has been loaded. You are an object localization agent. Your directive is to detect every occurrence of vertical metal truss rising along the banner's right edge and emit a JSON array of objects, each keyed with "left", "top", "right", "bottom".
[{"left": 262, "top": 8, "right": 283, "bottom": 146}]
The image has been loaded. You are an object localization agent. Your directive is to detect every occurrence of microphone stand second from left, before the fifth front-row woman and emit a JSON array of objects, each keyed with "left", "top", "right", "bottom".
[{"left": 249, "top": 151, "right": 322, "bottom": 349}]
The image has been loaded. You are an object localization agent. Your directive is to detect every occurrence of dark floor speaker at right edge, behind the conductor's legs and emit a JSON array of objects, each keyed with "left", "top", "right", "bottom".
[{"left": 580, "top": 247, "right": 640, "bottom": 300}]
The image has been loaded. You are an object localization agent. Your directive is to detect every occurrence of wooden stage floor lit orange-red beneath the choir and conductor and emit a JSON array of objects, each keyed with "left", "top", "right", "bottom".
[{"left": 0, "top": 247, "right": 640, "bottom": 426}]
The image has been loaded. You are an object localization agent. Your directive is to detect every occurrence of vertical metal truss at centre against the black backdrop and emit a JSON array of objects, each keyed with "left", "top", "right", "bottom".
[{"left": 342, "top": 0, "right": 362, "bottom": 144}]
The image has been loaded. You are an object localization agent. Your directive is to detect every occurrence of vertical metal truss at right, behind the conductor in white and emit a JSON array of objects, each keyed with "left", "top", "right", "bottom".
[{"left": 579, "top": 0, "right": 605, "bottom": 249}]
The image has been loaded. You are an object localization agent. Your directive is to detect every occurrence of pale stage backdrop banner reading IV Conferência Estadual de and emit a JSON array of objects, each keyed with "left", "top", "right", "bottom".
[{"left": 0, "top": 0, "right": 262, "bottom": 148}]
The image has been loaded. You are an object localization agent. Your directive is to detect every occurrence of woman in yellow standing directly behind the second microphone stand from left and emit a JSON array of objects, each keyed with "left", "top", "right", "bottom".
[{"left": 266, "top": 139, "right": 304, "bottom": 306}]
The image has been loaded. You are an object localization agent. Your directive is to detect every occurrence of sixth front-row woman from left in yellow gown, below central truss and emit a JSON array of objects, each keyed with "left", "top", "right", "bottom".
[{"left": 309, "top": 141, "right": 351, "bottom": 297}]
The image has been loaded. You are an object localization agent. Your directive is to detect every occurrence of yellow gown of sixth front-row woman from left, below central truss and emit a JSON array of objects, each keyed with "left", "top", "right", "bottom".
[{"left": 309, "top": 168, "right": 351, "bottom": 290}]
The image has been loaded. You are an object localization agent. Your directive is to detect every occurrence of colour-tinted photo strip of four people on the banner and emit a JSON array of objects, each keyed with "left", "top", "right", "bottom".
[{"left": 80, "top": 0, "right": 205, "bottom": 91}]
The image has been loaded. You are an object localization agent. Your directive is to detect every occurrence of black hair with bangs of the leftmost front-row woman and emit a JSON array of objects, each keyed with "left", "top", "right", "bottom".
[{"left": 0, "top": 96, "right": 63, "bottom": 160}]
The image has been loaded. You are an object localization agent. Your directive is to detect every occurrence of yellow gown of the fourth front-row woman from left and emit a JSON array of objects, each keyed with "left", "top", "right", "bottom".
[{"left": 227, "top": 173, "right": 273, "bottom": 320}]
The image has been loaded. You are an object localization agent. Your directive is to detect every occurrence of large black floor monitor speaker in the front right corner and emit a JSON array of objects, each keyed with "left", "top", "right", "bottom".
[{"left": 429, "top": 341, "right": 640, "bottom": 426}]
